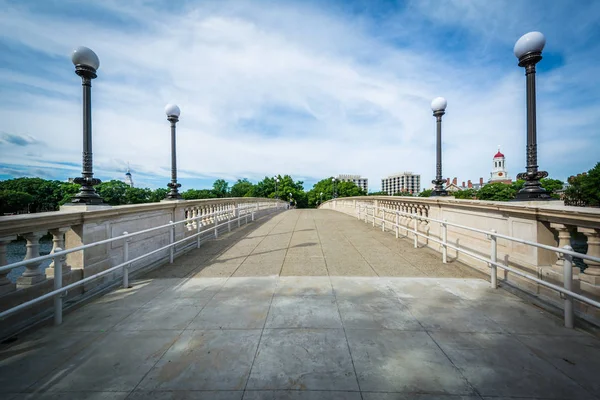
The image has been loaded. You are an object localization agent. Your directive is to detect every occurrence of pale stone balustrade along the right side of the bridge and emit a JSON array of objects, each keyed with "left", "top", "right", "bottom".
[{"left": 320, "top": 196, "right": 600, "bottom": 324}]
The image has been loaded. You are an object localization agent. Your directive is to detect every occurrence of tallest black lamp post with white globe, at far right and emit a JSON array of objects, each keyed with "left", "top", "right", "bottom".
[{"left": 514, "top": 32, "right": 551, "bottom": 201}]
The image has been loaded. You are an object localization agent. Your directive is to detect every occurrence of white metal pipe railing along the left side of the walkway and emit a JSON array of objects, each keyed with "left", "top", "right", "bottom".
[{"left": 0, "top": 203, "right": 279, "bottom": 325}]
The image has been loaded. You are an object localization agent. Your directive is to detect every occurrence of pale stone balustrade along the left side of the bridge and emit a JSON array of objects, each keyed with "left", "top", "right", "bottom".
[{"left": 0, "top": 198, "right": 286, "bottom": 337}]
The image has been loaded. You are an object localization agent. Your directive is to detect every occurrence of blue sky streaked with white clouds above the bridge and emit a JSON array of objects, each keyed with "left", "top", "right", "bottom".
[{"left": 0, "top": 0, "right": 600, "bottom": 191}]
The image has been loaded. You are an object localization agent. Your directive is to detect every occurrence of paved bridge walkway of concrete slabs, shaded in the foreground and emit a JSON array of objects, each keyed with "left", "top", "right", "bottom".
[{"left": 0, "top": 210, "right": 600, "bottom": 400}]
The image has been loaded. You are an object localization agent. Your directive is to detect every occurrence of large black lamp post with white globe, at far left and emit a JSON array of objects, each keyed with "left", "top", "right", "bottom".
[{"left": 71, "top": 46, "right": 105, "bottom": 205}]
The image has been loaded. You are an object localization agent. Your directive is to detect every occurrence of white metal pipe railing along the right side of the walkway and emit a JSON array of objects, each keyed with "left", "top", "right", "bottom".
[{"left": 357, "top": 204, "right": 600, "bottom": 328}]
